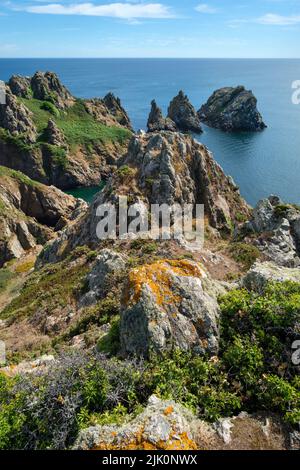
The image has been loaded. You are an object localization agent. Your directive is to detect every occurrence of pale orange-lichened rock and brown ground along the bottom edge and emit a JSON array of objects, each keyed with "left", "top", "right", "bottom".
[{"left": 74, "top": 395, "right": 292, "bottom": 451}]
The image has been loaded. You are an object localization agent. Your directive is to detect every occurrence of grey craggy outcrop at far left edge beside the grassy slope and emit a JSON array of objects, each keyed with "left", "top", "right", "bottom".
[{"left": 0, "top": 86, "right": 37, "bottom": 143}]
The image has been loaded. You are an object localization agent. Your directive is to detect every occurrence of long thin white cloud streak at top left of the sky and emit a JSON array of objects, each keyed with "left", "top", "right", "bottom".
[{"left": 22, "top": 3, "right": 175, "bottom": 19}]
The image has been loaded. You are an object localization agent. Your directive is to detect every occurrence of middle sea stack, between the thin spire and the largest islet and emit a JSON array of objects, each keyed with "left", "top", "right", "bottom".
[{"left": 168, "top": 91, "right": 202, "bottom": 134}]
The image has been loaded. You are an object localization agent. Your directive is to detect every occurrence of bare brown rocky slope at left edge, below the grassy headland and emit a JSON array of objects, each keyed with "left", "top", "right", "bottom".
[{"left": 0, "top": 167, "right": 87, "bottom": 266}]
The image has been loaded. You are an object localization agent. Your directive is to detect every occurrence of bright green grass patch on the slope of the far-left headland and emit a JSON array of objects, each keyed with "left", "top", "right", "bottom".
[{"left": 21, "top": 98, "right": 131, "bottom": 146}]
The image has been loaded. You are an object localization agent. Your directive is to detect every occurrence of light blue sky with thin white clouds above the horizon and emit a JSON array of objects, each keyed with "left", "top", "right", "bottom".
[{"left": 0, "top": 0, "right": 300, "bottom": 58}]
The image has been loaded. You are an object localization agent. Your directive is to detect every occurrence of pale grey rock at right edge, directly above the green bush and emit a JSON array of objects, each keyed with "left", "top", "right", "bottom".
[{"left": 241, "top": 262, "right": 300, "bottom": 293}]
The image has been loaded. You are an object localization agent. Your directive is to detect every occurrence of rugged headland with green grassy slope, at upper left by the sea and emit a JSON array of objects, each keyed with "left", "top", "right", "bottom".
[{"left": 0, "top": 72, "right": 132, "bottom": 189}]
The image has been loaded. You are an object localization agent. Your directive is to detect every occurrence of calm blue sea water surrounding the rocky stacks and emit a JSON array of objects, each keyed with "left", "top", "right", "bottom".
[{"left": 0, "top": 59, "right": 300, "bottom": 205}]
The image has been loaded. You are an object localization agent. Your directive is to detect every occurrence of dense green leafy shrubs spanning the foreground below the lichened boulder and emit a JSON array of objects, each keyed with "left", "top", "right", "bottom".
[{"left": 0, "top": 276, "right": 300, "bottom": 449}]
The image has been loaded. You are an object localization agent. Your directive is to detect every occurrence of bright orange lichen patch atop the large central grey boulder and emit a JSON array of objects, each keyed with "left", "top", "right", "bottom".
[{"left": 125, "top": 260, "right": 203, "bottom": 306}]
